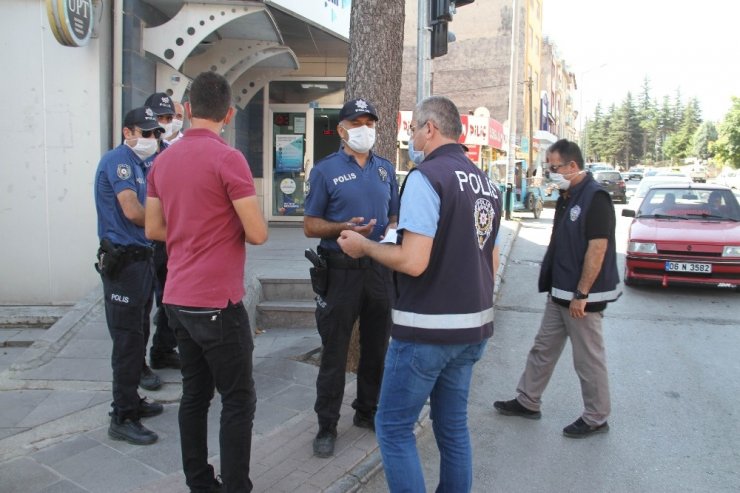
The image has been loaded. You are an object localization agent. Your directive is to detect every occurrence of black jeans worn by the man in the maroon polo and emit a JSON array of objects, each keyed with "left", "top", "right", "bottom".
[{"left": 164, "top": 302, "right": 257, "bottom": 493}]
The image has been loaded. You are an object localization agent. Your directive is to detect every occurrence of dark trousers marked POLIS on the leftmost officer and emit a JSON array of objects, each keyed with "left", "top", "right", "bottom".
[{"left": 101, "top": 259, "right": 154, "bottom": 419}]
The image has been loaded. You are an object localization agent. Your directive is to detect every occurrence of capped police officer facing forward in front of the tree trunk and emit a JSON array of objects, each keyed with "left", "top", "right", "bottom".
[{"left": 304, "top": 99, "right": 398, "bottom": 457}]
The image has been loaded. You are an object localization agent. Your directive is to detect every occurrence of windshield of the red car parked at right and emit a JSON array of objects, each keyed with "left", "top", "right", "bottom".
[{"left": 637, "top": 187, "right": 740, "bottom": 221}]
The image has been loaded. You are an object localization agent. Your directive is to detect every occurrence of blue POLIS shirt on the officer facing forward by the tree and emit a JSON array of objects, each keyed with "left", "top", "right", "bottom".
[{"left": 304, "top": 149, "right": 398, "bottom": 251}]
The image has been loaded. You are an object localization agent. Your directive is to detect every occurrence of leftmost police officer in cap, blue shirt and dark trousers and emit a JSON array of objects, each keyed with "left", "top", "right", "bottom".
[{"left": 95, "top": 107, "right": 164, "bottom": 445}]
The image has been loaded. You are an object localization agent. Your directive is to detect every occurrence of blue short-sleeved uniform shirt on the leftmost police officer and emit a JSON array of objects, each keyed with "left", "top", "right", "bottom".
[{"left": 95, "top": 144, "right": 150, "bottom": 246}]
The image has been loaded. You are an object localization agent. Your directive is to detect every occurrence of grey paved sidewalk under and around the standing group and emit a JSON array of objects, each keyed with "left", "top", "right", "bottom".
[{"left": 0, "top": 220, "right": 519, "bottom": 493}]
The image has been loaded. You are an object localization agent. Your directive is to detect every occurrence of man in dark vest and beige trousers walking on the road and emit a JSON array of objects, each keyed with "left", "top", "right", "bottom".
[{"left": 493, "top": 139, "right": 620, "bottom": 438}]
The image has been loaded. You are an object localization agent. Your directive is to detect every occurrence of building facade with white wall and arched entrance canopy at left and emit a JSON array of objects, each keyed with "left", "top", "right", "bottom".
[{"left": 0, "top": 0, "right": 351, "bottom": 305}]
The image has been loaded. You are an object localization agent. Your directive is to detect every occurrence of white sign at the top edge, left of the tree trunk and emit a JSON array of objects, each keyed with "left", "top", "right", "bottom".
[{"left": 265, "top": 0, "right": 352, "bottom": 40}]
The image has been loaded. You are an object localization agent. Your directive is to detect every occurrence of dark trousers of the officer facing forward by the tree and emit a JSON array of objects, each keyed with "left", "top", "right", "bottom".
[{"left": 314, "top": 262, "right": 391, "bottom": 427}]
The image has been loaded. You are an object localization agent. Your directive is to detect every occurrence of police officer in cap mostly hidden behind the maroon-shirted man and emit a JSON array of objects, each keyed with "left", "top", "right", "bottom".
[{"left": 140, "top": 92, "right": 182, "bottom": 376}]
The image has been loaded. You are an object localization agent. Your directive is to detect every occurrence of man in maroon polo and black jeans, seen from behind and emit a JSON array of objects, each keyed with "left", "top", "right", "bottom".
[{"left": 145, "top": 72, "right": 267, "bottom": 492}]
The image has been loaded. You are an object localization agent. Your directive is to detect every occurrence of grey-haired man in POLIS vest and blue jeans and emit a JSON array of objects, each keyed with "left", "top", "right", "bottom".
[{"left": 338, "top": 96, "right": 501, "bottom": 492}]
